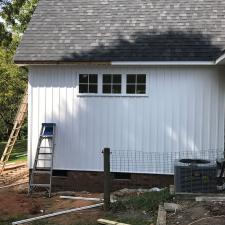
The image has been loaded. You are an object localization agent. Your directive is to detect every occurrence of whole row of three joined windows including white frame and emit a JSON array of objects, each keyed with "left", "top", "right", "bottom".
[{"left": 78, "top": 72, "right": 149, "bottom": 97}]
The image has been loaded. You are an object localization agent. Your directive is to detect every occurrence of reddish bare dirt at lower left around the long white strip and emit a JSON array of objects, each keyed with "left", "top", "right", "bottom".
[{"left": 0, "top": 184, "right": 104, "bottom": 225}]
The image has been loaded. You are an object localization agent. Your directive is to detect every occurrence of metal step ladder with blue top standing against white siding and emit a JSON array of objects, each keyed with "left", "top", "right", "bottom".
[{"left": 28, "top": 123, "right": 56, "bottom": 197}]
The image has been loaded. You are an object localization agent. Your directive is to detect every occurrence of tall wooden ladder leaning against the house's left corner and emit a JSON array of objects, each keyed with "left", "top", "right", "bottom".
[{"left": 0, "top": 90, "right": 28, "bottom": 176}]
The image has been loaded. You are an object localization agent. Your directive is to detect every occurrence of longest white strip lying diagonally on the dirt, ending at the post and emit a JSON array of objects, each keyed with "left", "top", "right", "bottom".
[{"left": 12, "top": 203, "right": 103, "bottom": 225}]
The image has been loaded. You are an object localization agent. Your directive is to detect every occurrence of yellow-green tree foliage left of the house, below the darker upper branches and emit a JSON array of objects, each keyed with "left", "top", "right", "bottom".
[{"left": 0, "top": 41, "right": 27, "bottom": 139}]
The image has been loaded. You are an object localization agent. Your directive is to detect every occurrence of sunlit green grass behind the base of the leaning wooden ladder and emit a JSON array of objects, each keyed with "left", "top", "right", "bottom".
[{"left": 0, "top": 140, "right": 27, "bottom": 162}]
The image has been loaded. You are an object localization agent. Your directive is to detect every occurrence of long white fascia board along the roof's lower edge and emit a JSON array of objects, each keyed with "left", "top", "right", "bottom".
[{"left": 111, "top": 61, "right": 215, "bottom": 66}]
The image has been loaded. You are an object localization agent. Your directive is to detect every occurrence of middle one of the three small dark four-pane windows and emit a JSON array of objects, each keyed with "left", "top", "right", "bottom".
[{"left": 102, "top": 74, "right": 121, "bottom": 94}]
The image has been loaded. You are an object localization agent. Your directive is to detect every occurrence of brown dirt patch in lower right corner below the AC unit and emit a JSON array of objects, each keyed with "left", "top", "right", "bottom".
[{"left": 167, "top": 201, "right": 225, "bottom": 225}]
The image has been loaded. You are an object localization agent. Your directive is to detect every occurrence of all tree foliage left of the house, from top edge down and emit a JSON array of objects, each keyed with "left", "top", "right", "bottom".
[{"left": 0, "top": 0, "right": 38, "bottom": 140}]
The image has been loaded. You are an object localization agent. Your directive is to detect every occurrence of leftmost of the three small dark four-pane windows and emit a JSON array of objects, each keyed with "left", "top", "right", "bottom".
[{"left": 79, "top": 74, "right": 98, "bottom": 94}]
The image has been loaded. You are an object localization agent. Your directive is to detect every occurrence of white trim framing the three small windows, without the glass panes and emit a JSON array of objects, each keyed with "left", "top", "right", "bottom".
[{"left": 77, "top": 73, "right": 150, "bottom": 97}]
